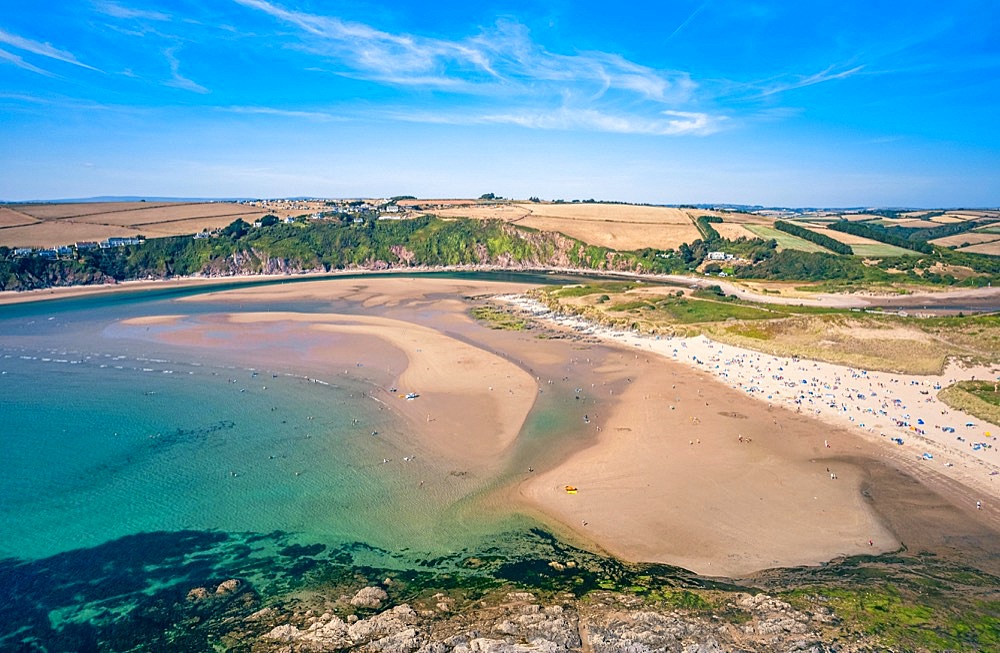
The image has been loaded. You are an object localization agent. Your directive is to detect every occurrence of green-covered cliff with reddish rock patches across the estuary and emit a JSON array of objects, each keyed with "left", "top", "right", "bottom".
[{"left": 0, "top": 223, "right": 664, "bottom": 290}]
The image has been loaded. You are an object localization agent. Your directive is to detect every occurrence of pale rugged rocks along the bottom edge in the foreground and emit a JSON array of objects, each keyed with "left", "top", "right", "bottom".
[{"left": 254, "top": 588, "right": 860, "bottom": 653}]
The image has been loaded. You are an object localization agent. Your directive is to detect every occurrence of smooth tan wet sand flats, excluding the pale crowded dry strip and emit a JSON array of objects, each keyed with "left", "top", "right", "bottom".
[{"left": 64, "top": 277, "right": 1000, "bottom": 576}]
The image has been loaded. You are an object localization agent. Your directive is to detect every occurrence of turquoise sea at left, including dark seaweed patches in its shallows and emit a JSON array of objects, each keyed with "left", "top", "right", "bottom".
[{"left": 0, "top": 282, "right": 572, "bottom": 648}]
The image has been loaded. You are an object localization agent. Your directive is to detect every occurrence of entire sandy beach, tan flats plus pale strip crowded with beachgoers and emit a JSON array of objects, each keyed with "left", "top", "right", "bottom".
[{"left": 23, "top": 277, "right": 1000, "bottom": 577}]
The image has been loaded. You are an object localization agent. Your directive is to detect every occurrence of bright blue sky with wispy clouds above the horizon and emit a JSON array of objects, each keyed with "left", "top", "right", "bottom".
[{"left": 0, "top": 0, "right": 1000, "bottom": 207}]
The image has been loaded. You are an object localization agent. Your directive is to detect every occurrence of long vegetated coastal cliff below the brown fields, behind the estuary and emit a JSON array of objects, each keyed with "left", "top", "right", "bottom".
[{"left": 0, "top": 217, "right": 671, "bottom": 291}]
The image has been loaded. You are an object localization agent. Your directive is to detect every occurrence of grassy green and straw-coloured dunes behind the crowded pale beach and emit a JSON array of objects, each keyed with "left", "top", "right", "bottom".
[{"left": 536, "top": 283, "right": 1000, "bottom": 374}]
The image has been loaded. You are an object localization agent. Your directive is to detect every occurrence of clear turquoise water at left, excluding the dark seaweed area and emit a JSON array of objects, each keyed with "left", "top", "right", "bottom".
[{"left": 0, "top": 294, "right": 532, "bottom": 558}]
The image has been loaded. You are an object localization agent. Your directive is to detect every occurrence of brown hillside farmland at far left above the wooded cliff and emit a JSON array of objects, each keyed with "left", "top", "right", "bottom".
[{"left": 0, "top": 202, "right": 268, "bottom": 247}]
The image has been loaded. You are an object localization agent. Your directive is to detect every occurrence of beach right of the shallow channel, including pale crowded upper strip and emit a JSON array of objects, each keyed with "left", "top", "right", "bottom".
[{"left": 507, "top": 297, "right": 1000, "bottom": 575}]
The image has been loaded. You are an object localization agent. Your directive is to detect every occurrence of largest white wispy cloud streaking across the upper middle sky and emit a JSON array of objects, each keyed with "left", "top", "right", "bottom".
[{"left": 234, "top": 0, "right": 723, "bottom": 135}]
